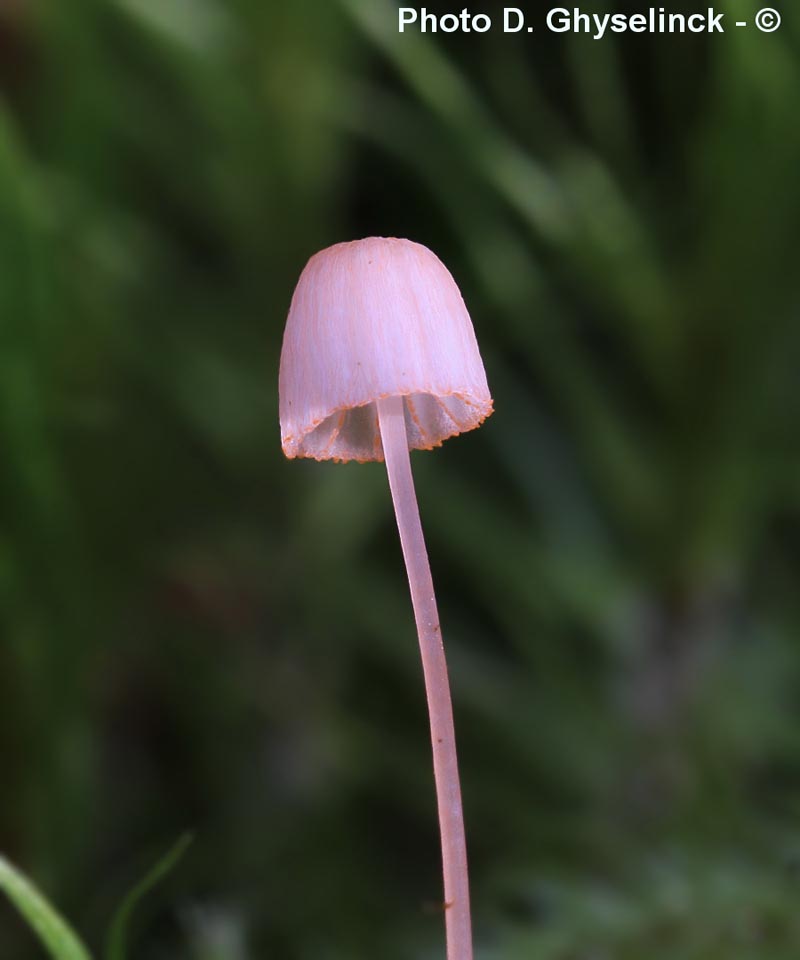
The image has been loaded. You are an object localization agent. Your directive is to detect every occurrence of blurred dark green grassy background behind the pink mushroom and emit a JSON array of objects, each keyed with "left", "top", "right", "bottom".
[{"left": 0, "top": 0, "right": 800, "bottom": 960}]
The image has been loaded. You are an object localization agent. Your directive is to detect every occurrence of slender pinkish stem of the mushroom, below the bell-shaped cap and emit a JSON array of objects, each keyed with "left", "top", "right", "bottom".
[{"left": 376, "top": 397, "right": 472, "bottom": 960}]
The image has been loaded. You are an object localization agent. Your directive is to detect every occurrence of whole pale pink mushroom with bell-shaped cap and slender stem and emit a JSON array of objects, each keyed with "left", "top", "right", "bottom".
[{"left": 279, "top": 237, "right": 492, "bottom": 960}]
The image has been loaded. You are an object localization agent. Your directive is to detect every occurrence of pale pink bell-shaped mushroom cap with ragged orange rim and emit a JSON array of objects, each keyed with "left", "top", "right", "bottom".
[{"left": 279, "top": 237, "right": 492, "bottom": 460}]
